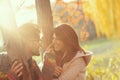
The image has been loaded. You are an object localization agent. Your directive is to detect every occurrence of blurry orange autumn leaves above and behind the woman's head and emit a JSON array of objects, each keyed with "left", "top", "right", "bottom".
[{"left": 53, "top": 0, "right": 96, "bottom": 41}]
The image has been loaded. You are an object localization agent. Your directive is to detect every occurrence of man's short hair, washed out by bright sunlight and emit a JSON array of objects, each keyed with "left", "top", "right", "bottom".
[{"left": 18, "top": 23, "right": 40, "bottom": 40}]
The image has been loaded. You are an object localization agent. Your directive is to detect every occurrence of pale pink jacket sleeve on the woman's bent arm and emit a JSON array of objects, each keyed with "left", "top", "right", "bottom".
[{"left": 53, "top": 57, "right": 86, "bottom": 80}]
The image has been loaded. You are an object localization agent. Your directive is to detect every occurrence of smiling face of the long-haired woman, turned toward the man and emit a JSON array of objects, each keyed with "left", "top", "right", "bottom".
[{"left": 53, "top": 34, "right": 65, "bottom": 51}]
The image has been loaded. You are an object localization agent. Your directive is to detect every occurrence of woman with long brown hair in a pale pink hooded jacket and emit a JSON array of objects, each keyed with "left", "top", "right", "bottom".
[{"left": 42, "top": 24, "right": 91, "bottom": 80}]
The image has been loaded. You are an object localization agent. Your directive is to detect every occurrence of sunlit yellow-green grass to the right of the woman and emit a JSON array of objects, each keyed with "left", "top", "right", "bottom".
[{"left": 81, "top": 39, "right": 120, "bottom": 80}]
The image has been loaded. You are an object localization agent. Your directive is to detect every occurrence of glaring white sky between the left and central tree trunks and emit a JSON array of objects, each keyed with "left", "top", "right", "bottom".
[{"left": 11, "top": 0, "right": 37, "bottom": 27}]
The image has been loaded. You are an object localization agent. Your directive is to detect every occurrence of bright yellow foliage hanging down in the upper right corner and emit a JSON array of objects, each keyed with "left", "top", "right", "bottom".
[{"left": 83, "top": 0, "right": 120, "bottom": 38}]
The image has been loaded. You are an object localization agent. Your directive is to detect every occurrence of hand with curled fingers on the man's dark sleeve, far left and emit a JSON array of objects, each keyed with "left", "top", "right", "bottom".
[{"left": 10, "top": 60, "right": 23, "bottom": 77}]
